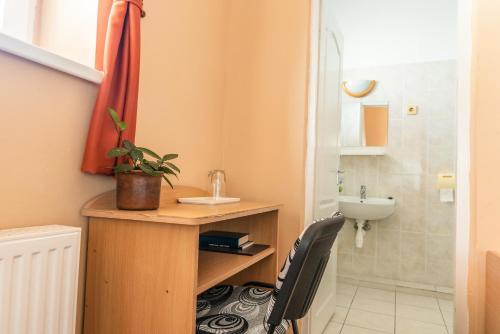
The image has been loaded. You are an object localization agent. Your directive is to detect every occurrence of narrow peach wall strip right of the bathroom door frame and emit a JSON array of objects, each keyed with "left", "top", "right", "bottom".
[{"left": 469, "top": 0, "right": 500, "bottom": 334}]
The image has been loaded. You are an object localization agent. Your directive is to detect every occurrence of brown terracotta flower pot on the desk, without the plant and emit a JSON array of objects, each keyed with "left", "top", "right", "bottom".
[{"left": 116, "top": 171, "right": 161, "bottom": 210}]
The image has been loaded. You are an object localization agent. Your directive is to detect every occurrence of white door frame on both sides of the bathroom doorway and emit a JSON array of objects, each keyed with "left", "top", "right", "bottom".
[{"left": 304, "top": 0, "right": 474, "bottom": 334}]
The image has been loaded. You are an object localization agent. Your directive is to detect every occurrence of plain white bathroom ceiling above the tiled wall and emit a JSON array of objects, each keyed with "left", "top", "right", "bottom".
[{"left": 331, "top": 0, "right": 458, "bottom": 68}]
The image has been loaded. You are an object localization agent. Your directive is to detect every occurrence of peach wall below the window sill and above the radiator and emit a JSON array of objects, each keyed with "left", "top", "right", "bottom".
[{"left": 0, "top": 52, "right": 114, "bottom": 332}]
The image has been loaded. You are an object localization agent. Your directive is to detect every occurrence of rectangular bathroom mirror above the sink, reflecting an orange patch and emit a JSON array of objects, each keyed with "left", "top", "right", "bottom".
[{"left": 340, "top": 102, "right": 389, "bottom": 147}]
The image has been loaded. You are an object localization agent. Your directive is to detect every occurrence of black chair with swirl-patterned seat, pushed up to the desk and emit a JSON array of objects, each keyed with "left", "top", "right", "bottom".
[{"left": 196, "top": 212, "right": 344, "bottom": 334}]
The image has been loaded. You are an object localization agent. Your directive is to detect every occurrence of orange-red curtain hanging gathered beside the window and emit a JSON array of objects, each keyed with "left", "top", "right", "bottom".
[{"left": 82, "top": 0, "right": 142, "bottom": 175}]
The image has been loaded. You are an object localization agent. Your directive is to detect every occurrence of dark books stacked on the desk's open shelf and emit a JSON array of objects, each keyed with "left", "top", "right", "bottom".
[{"left": 200, "top": 231, "right": 269, "bottom": 255}]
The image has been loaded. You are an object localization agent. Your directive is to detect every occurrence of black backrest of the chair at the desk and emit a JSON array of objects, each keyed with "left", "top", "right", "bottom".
[{"left": 266, "top": 213, "right": 345, "bottom": 326}]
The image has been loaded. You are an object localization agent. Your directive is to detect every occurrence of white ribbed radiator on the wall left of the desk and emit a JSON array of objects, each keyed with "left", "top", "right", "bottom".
[{"left": 0, "top": 225, "right": 81, "bottom": 334}]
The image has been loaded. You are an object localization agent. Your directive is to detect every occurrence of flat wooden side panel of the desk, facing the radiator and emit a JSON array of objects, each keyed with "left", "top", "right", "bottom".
[{"left": 84, "top": 218, "right": 199, "bottom": 334}]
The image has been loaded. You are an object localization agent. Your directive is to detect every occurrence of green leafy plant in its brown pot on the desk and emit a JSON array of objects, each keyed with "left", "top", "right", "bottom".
[{"left": 108, "top": 108, "right": 180, "bottom": 210}]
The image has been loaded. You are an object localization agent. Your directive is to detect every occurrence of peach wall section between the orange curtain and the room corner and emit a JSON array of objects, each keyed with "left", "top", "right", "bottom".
[{"left": 136, "top": 0, "right": 228, "bottom": 187}]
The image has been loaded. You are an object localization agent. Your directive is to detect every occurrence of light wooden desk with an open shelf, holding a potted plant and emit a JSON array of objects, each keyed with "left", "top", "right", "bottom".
[{"left": 82, "top": 187, "right": 281, "bottom": 334}]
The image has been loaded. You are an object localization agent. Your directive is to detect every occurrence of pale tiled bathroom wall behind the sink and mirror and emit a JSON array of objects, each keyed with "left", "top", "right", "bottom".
[{"left": 339, "top": 61, "right": 456, "bottom": 287}]
